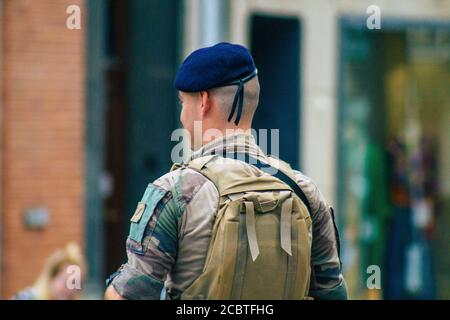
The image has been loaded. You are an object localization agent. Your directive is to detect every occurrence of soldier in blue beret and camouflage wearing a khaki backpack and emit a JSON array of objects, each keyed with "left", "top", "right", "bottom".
[{"left": 105, "top": 43, "right": 347, "bottom": 299}]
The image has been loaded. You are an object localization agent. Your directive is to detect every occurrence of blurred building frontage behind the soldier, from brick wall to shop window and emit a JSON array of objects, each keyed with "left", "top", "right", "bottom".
[{"left": 0, "top": 0, "right": 450, "bottom": 299}]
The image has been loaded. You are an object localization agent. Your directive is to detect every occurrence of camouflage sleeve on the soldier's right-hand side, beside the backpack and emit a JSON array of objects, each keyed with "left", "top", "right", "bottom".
[{"left": 295, "top": 171, "right": 348, "bottom": 300}]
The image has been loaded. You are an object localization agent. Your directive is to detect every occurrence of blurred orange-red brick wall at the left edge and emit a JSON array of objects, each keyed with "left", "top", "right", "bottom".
[{"left": 0, "top": 0, "right": 86, "bottom": 298}]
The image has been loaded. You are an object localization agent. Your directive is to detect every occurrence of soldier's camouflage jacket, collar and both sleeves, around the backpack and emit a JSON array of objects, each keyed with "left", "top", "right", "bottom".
[{"left": 111, "top": 134, "right": 347, "bottom": 299}]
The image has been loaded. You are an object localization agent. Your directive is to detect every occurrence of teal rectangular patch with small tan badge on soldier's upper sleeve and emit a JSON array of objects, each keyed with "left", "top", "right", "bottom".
[{"left": 128, "top": 183, "right": 168, "bottom": 243}]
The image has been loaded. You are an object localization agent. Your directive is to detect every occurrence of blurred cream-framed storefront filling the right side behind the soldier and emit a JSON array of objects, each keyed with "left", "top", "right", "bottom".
[{"left": 219, "top": 0, "right": 450, "bottom": 299}]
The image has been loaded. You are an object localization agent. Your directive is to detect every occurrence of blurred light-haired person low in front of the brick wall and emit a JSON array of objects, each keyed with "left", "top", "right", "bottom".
[{"left": 12, "top": 243, "right": 86, "bottom": 300}]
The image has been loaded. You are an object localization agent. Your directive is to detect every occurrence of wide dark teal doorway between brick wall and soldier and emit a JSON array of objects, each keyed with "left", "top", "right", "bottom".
[{"left": 86, "top": 0, "right": 180, "bottom": 292}]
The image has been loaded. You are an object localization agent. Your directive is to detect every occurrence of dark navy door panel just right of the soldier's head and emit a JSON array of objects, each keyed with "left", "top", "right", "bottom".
[{"left": 250, "top": 14, "right": 301, "bottom": 169}]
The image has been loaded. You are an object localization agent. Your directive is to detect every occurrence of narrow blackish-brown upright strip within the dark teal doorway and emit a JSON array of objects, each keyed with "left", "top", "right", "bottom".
[{"left": 101, "top": 1, "right": 129, "bottom": 276}]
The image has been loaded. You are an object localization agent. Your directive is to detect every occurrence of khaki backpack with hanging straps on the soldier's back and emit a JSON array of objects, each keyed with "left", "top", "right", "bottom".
[{"left": 173, "top": 155, "right": 311, "bottom": 300}]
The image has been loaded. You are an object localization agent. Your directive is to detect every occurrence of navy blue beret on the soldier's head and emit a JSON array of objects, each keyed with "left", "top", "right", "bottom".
[{"left": 175, "top": 42, "right": 256, "bottom": 92}]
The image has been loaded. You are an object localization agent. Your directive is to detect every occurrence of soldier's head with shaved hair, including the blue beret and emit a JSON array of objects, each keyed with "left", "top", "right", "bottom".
[{"left": 175, "top": 43, "right": 260, "bottom": 149}]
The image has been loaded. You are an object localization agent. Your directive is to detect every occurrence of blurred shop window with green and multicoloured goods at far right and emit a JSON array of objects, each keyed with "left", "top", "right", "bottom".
[{"left": 338, "top": 19, "right": 450, "bottom": 299}]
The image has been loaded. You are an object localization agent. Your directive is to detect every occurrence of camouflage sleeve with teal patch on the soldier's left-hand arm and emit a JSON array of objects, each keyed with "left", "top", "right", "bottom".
[{"left": 111, "top": 181, "right": 182, "bottom": 300}]
